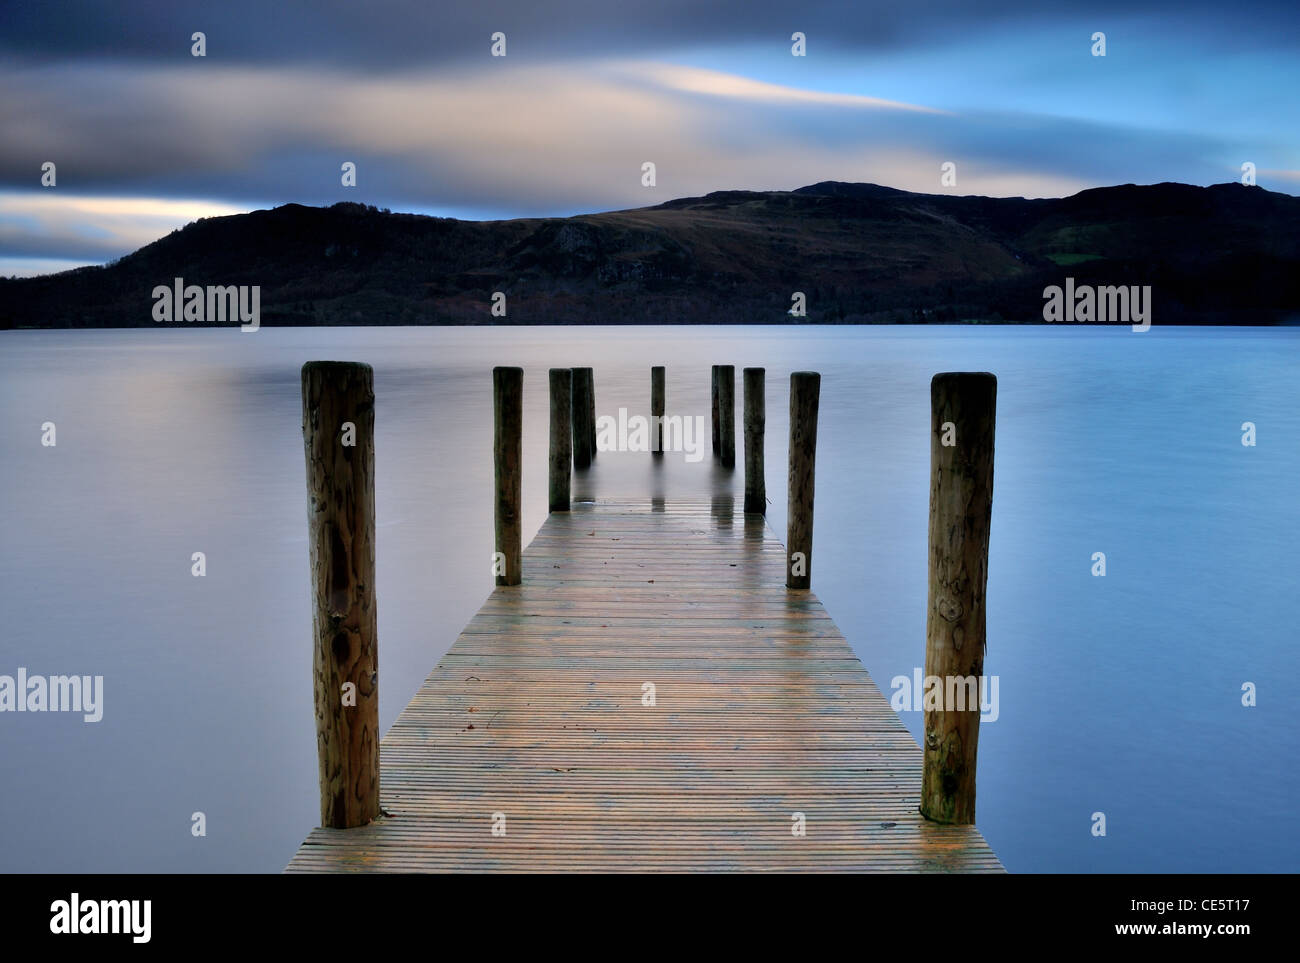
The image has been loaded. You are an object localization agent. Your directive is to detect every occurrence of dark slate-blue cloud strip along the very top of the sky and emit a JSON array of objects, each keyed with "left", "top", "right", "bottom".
[{"left": 0, "top": 0, "right": 1296, "bottom": 69}]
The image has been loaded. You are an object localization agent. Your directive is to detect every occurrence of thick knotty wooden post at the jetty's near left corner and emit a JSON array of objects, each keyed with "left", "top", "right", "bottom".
[{"left": 303, "top": 361, "right": 380, "bottom": 829}]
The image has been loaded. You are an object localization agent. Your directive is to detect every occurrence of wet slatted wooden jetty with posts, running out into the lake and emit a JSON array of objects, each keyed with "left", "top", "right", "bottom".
[{"left": 287, "top": 369, "right": 1002, "bottom": 872}]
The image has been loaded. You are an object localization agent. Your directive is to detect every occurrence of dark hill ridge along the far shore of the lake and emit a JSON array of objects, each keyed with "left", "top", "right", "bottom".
[{"left": 0, "top": 181, "right": 1300, "bottom": 327}]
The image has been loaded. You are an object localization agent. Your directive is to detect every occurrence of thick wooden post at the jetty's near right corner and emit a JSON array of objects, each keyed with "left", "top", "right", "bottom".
[{"left": 920, "top": 372, "right": 997, "bottom": 824}]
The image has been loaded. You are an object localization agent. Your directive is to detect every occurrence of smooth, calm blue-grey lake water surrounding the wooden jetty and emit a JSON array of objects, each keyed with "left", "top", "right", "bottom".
[{"left": 0, "top": 326, "right": 1300, "bottom": 872}]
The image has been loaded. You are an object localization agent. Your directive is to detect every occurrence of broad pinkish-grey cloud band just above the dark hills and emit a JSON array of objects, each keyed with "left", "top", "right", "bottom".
[{"left": 0, "top": 61, "right": 1226, "bottom": 214}]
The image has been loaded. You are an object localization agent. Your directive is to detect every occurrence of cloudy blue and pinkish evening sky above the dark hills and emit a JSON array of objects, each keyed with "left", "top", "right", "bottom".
[{"left": 0, "top": 0, "right": 1300, "bottom": 276}]
